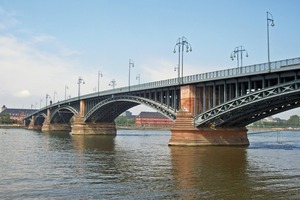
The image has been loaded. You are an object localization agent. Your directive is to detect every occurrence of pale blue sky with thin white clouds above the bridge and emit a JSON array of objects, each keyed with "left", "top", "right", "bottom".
[{"left": 0, "top": 0, "right": 300, "bottom": 118}]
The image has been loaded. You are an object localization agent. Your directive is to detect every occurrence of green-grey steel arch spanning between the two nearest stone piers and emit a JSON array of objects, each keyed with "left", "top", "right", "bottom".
[{"left": 84, "top": 95, "right": 176, "bottom": 122}]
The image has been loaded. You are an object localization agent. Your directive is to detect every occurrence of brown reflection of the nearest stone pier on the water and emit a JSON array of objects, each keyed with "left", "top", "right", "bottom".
[{"left": 171, "top": 147, "right": 249, "bottom": 199}]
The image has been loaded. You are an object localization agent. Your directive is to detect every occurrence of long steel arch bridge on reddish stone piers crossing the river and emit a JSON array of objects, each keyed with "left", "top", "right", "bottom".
[{"left": 25, "top": 57, "right": 300, "bottom": 146}]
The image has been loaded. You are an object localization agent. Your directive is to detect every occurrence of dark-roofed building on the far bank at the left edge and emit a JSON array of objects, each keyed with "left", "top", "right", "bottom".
[{"left": 0, "top": 105, "right": 37, "bottom": 124}]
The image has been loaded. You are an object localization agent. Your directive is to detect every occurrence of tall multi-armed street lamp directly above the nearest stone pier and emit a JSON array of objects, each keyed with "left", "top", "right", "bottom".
[{"left": 173, "top": 36, "right": 192, "bottom": 83}]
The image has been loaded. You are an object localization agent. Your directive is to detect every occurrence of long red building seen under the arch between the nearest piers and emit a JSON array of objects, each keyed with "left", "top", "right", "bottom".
[{"left": 135, "top": 112, "right": 174, "bottom": 127}]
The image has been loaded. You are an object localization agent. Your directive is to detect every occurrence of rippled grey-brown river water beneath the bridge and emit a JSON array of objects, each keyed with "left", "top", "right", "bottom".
[{"left": 0, "top": 129, "right": 300, "bottom": 200}]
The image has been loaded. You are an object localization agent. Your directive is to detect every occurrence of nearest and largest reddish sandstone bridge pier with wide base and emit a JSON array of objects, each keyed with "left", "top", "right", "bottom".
[{"left": 169, "top": 85, "right": 249, "bottom": 146}]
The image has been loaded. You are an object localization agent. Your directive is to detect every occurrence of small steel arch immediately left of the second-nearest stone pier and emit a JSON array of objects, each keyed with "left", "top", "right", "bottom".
[{"left": 50, "top": 106, "right": 79, "bottom": 124}]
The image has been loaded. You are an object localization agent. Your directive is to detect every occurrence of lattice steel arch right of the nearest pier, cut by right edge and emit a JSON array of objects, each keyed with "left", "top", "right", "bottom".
[{"left": 194, "top": 80, "right": 300, "bottom": 128}]
